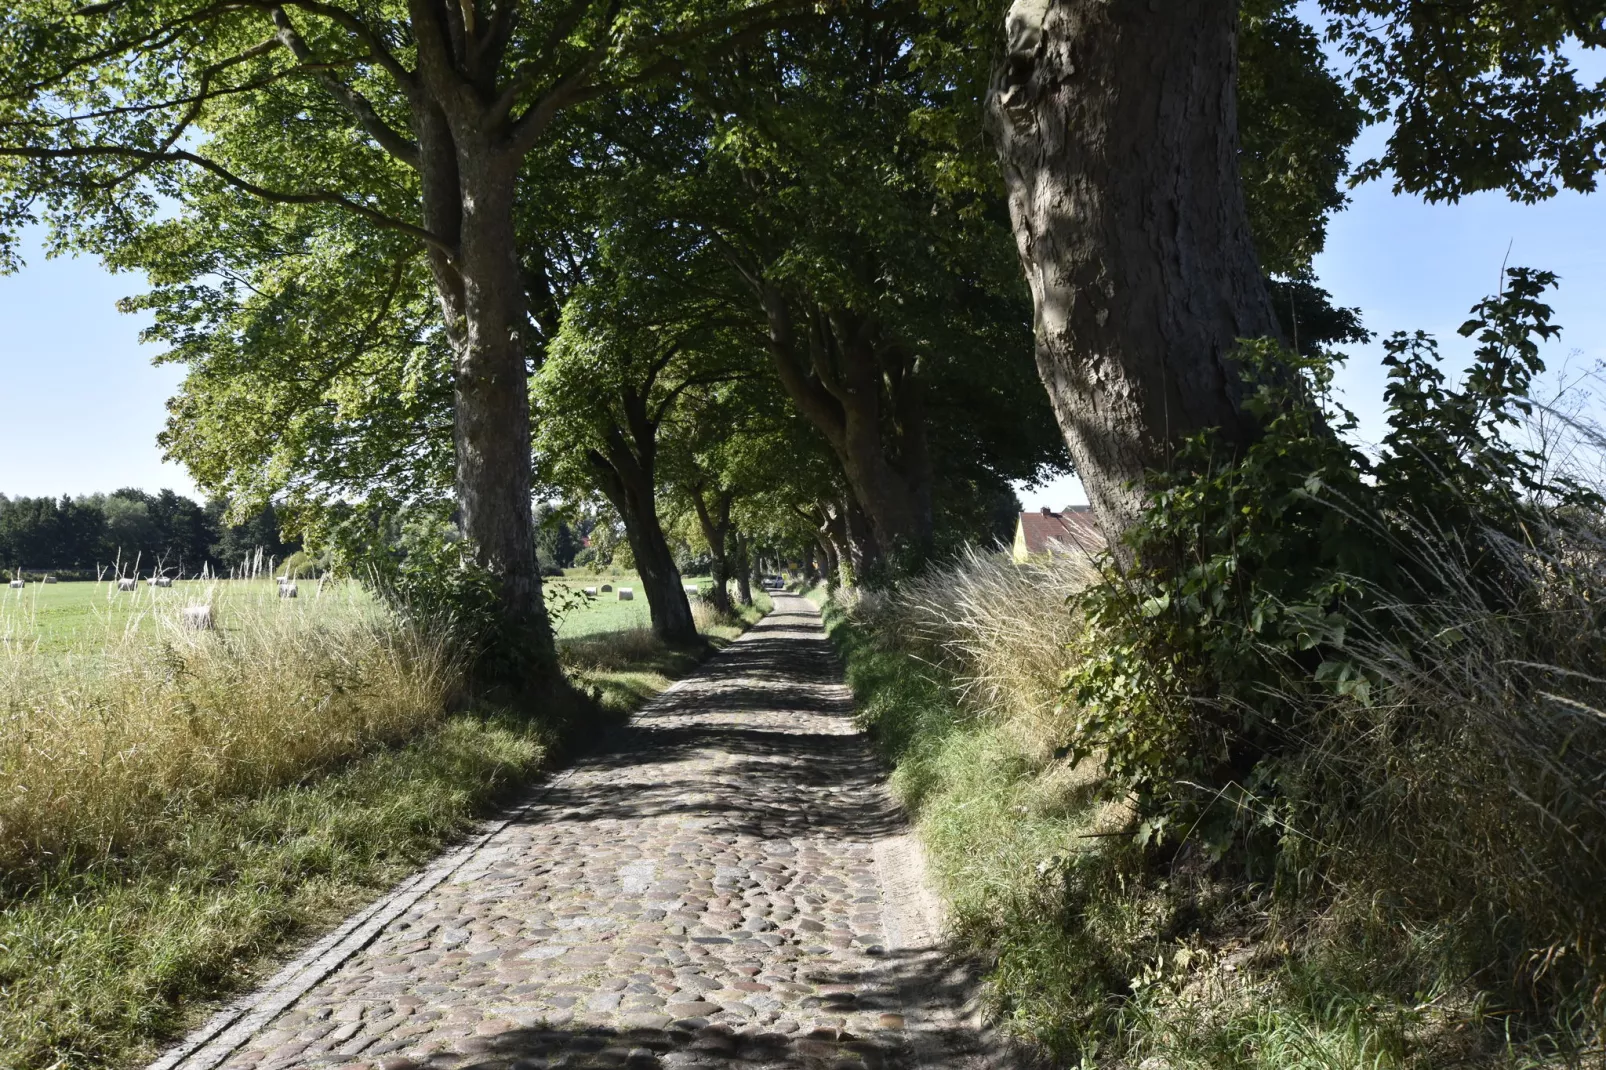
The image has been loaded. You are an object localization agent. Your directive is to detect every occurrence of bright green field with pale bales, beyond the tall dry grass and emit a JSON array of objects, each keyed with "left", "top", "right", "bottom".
[{"left": 0, "top": 570, "right": 707, "bottom": 654}]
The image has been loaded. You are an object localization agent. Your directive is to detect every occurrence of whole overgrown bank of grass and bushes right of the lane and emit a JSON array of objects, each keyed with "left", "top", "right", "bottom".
[{"left": 837, "top": 272, "right": 1606, "bottom": 1070}]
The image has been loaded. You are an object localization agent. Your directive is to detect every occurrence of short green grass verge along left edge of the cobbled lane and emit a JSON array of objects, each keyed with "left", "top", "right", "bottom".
[{"left": 0, "top": 585, "right": 768, "bottom": 1070}]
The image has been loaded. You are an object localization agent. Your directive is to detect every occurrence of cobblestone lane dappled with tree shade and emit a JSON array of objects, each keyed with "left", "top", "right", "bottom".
[{"left": 153, "top": 594, "right": 994, "bottom": 1070}]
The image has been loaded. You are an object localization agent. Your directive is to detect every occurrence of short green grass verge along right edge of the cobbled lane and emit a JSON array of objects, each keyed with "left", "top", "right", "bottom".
[{"left": 827, "top": 591, "right": 1606, "bottom": 1070}]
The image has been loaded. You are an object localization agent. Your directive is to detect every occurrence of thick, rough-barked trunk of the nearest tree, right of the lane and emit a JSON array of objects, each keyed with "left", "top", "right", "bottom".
[{"left": 988, "top": 0, "right": 1278, "bottom": 545}]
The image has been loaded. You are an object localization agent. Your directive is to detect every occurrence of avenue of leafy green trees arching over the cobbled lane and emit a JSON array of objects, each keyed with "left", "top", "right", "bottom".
[{"left": 0, "top": 0, "right": 1606, "bottom": 674}]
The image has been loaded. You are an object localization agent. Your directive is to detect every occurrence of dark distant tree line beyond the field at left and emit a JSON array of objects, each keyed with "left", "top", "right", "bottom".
[{"left": 0, "top": 488, "right": 300, "bottom": 575}]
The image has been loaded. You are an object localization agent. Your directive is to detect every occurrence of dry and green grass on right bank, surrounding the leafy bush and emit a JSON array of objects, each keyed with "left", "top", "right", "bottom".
[{"left": 835, "top": 509, "right": 1606, "bottom": 1068}]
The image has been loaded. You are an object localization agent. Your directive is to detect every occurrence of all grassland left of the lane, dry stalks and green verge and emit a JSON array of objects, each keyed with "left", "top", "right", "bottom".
[{"left": 0, "top": 577, "right": 758, "bottom": 1070}]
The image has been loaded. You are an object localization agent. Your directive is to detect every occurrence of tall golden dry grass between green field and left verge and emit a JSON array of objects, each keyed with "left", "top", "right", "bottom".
[{"left": 0, "top": 582, "right": 458, "bottom": 882}]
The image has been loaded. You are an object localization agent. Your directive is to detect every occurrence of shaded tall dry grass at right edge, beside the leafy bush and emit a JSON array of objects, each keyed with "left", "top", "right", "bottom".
[{"left": 1278, "top": 509, "right": 1606, "bottom": 1031}]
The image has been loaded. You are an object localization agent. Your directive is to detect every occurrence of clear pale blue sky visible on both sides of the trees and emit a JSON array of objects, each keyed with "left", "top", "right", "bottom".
[{"left": 0, "top": 143, "right": 1606, "bottom": 508}]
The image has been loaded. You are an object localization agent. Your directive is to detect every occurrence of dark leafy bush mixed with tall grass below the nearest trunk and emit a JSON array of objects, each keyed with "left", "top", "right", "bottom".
[{"left": 1066, "top": 268, "right": 1606, "bottom": 1027}]
